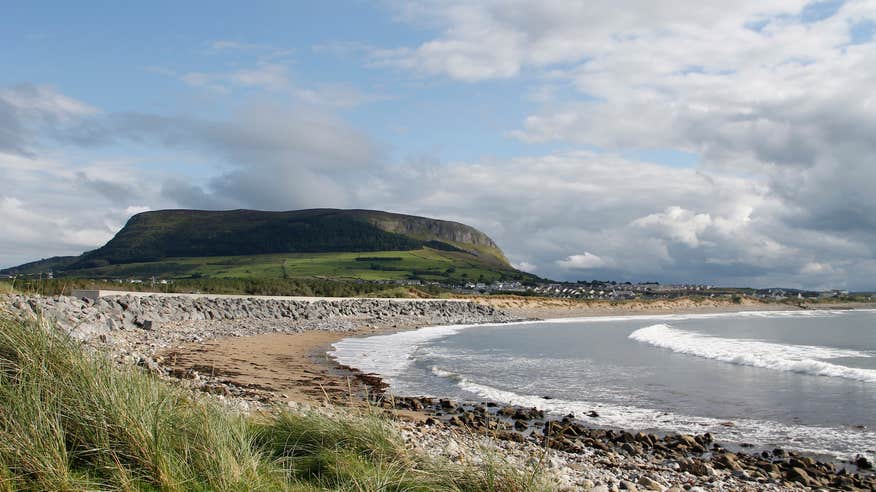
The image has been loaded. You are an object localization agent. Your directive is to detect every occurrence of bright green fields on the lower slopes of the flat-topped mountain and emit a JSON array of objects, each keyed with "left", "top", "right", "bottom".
[{"left": 39, "top": 248, "right": 531, "bottom": 283}]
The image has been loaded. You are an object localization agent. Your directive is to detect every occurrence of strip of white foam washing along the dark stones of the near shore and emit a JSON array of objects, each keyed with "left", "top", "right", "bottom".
[{"left": 457, "top": 377, "right": 876, "bottom": 459}]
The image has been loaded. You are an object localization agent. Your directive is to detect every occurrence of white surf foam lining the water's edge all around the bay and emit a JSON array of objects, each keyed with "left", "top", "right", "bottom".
[{"left": 329, "top": 310, "right": 876, "bottom": 457}]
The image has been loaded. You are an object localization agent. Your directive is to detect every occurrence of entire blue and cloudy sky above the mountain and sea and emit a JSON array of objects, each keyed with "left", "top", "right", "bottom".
[{"left": 0, "top": 0, "right": 876, "bottom": 290}]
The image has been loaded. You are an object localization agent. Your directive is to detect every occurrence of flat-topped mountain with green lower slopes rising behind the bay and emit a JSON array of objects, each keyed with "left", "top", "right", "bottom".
[{"left": 4, "top": 209, "right": 522, "bottom": 280}]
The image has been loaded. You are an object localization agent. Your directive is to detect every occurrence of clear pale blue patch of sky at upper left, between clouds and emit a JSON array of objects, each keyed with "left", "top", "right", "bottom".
[{"left": 0, "top": 2, "right": 556, "bottom": 165}]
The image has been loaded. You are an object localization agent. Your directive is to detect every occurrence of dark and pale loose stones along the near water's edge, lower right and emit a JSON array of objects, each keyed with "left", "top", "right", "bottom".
[{"left": 392, "top": 397, "right": 876, "bottom": 492}]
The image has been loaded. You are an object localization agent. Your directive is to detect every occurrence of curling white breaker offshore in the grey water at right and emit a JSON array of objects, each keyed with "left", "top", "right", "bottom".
[{"left": 629, "top": 324, "right": 876, "bottom": 383}]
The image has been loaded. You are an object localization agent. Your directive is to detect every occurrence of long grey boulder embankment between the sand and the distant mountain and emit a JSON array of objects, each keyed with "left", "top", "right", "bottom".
[{"left": 5, "top": 295, "right": 510, "bottom": 369}]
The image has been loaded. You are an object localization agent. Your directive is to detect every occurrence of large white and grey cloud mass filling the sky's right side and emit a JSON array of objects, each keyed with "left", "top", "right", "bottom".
[{"left": 370, "top": 0, "right": 876, "bottom": 286}]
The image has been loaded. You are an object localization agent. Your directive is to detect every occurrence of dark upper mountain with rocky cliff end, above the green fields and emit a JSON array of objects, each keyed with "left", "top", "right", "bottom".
[{"left": 68, "top": 209, "right": 509, "bottom": 269}]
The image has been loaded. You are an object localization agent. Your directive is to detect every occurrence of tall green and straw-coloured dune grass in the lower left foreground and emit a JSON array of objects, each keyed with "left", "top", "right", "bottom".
[{"left": 0, "top": 314, "right": 545, "bottom": 491}]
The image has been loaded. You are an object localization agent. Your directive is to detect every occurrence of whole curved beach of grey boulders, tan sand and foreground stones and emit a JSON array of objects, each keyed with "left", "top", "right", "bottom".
[{"left": 6, "top": 296, "right": 874, "bottom": 491}]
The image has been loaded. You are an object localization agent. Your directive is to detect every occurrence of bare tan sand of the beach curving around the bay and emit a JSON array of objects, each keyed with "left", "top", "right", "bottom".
[{"left": 161, "top": 296, "right": 860, "bottom": 405}]
